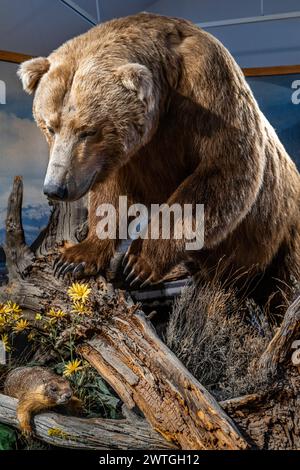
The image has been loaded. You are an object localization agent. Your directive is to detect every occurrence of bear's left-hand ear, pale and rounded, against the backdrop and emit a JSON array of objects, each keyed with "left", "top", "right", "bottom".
[{"left": 17, "top": 57, "right": 50, "bottom": 94}]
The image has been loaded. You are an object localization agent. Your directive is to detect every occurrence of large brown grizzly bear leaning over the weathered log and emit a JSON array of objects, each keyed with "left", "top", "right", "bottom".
[{"left": 19, "top": 13, "right": 300, "bottom": 308}]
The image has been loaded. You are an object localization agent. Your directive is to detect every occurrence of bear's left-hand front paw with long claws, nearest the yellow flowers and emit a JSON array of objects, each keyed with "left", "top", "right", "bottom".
[{"left": 54, "top": 236, "right": 116, "bottom": 278}]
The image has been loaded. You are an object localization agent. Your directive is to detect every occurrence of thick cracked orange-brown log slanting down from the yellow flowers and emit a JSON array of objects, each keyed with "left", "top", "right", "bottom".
[{"left": 79, "top": 312, "right": 248, "bottom": 450}]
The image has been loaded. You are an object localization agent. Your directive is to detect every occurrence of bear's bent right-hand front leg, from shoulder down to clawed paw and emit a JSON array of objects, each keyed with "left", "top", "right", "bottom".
[{"left": 124, "top": 149, "right": 264, "bottom": 286}]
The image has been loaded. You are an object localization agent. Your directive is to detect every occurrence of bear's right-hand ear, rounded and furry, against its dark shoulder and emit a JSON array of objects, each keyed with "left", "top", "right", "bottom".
[{"left": 117, "top": 63, "right": 155, "bottom": 112}]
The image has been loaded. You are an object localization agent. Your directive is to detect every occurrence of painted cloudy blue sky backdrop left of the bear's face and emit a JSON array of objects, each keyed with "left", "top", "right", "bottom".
[{"left": 0, "top": 62, "right": 49, "bottom": 250}]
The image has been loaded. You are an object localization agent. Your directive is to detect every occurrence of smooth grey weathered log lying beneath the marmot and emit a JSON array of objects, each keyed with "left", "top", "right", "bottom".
[{"left": 0, "top": 394, "right": 174, "bottom": 450}]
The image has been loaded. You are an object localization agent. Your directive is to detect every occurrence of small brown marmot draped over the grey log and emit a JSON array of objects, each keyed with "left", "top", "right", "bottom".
[{"left": 4, "top": 366, "right": 81, "bottom": 433}]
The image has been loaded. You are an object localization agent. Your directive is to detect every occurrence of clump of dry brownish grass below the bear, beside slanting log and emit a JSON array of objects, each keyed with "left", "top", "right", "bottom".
[{"left": 165, "top": 282, "right": 274, "bottom": 401}]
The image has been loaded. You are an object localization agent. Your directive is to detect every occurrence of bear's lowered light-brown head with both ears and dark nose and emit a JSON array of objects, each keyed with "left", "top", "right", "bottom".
[{"left": 19, "top": 51, "right": 159, "bottom": 201}]
